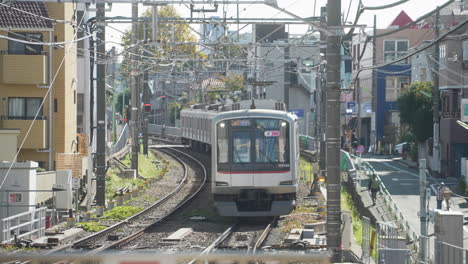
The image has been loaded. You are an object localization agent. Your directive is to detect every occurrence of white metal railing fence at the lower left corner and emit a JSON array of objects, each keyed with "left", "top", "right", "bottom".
[{"left": 0, "top": 207, "right": 47, "bottom": 243}]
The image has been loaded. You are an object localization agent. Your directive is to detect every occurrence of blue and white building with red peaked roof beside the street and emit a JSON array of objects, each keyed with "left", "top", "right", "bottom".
[{"left": 352, "top": 11, "right": 434, "bottom": 151}]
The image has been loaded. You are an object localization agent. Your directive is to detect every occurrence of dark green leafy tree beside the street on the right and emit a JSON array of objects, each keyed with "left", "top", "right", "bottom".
[{"left": 397, "top": 82, "right": 433, "bottom": 143}]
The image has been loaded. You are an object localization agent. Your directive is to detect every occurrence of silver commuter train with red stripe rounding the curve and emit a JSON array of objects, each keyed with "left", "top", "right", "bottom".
[{"left": 181, "top": 100, "right": 299, "bottom": 217}]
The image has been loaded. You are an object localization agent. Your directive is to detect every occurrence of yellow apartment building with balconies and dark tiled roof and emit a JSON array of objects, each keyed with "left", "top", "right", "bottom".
[{"left": 0, "top": 2, "right": 81, "bottom": 175}]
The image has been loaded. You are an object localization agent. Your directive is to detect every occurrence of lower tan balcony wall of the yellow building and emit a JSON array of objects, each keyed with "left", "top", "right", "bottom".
[{"left": 0, "top": 116, "right": 47, "bottom": 149}]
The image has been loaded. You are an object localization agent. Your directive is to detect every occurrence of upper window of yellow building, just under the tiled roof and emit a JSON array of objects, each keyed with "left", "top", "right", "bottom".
[{"left": 8, "top": 32, "right": 42, "bottom": 55}]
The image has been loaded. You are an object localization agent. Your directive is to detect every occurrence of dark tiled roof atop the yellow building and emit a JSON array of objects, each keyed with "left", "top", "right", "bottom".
[{"left": 0, "top": 2, "right": 53, "bottom": 29}]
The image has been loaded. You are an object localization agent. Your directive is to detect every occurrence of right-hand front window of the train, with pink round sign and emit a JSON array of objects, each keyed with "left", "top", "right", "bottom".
[{"left": 255, "top": 119, "right": 289, "bottom": 163}]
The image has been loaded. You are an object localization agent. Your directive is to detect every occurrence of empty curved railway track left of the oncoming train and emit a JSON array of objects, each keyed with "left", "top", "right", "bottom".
[{"left": 40, "top": 149, "right": 207, "bottom": 255}]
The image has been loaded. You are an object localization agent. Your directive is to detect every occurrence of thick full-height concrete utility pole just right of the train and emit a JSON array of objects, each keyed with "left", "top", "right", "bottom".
[{"left": 326, "top": 0, "right": 342, "bottom": 262}]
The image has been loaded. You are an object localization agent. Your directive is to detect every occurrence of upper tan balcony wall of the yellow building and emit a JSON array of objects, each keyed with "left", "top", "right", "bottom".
[{"left": 0, "top": 52, "right": 48, "bottom": 85}]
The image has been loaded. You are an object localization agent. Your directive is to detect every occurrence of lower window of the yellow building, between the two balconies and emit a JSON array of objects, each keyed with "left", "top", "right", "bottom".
[{"left": 8, "top": 97, "right": 43, "bottom": 120}]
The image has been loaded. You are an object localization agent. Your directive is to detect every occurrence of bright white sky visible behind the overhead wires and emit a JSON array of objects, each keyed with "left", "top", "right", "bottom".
[{"left": 106, "top": 0, "right": 447, "bottom": 48}]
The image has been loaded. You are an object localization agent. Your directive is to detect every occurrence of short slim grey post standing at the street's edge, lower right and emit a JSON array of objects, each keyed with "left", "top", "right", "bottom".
[{"left": 419, "top": 159, "right": 428, "bottom": 263}]
